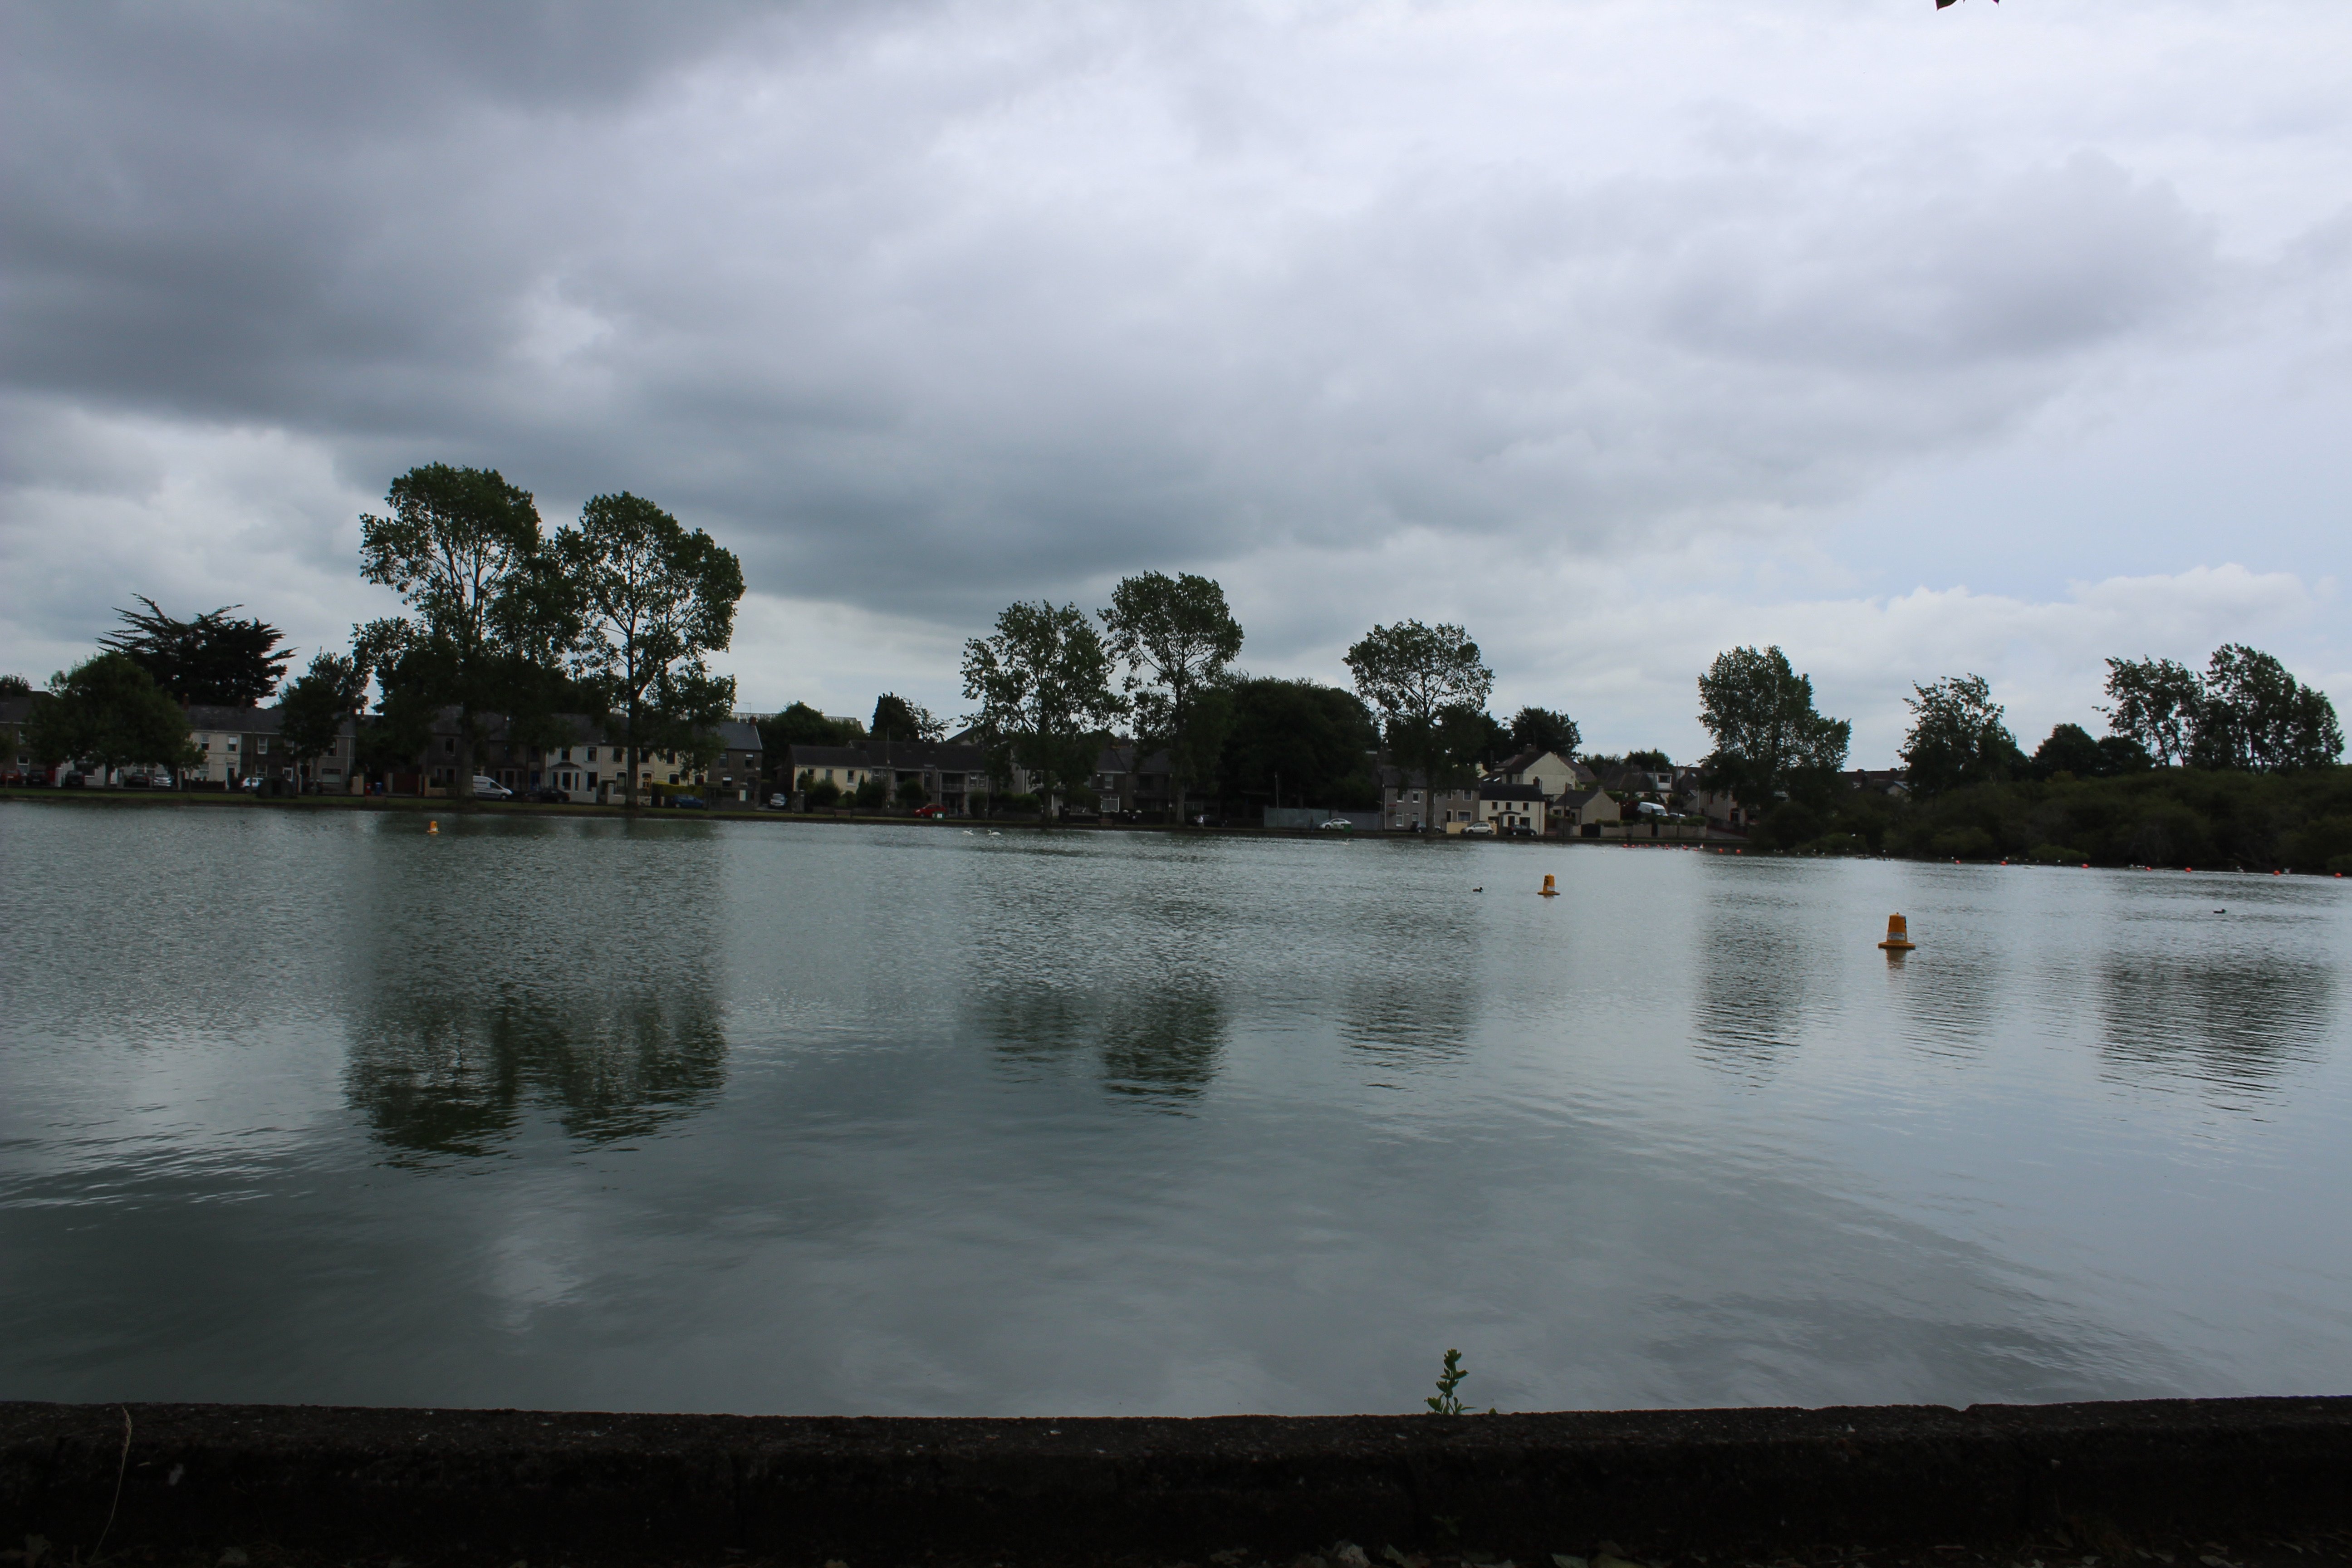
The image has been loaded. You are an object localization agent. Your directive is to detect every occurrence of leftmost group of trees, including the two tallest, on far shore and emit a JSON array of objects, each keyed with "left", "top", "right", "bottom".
[{"left": 9, "top": 463, "right": 743, "bottom": 804}]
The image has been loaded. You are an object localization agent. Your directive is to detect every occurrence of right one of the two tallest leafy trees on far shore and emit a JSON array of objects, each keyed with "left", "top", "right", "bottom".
[{"left": 555, "top": 491, "right": 743, "bottom": 806}]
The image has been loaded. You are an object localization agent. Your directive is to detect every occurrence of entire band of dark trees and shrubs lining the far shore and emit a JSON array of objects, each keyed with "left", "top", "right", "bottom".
[{"left": 0, "top": 463, "right": 2352, "bottom": 851}]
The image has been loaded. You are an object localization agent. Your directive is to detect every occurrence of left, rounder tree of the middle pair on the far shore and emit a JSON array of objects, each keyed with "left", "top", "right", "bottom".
[{"left": 964, "top": 599, "right": 1127, "bottom": 823}]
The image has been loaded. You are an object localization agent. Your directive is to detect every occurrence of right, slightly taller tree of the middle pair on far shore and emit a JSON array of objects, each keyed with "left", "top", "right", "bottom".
[{"left": 1101, "top": 571, "right": 1242, "bottom": 820}]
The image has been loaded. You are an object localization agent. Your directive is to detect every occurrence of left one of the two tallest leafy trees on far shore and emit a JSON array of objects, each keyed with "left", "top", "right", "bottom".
[{"left": 360, "top": 463, "right": 564, "bottom": 797}]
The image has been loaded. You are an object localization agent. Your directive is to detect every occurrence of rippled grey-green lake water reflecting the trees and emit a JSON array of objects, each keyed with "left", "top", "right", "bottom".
[{"left": 0, "top": 804, "right": 2352, "bottom": 1415}]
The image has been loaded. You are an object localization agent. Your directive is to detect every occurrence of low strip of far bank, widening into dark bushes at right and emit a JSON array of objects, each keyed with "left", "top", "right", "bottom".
[{"left": 0, "top": 769, "right": 2352, "bottom": 877}]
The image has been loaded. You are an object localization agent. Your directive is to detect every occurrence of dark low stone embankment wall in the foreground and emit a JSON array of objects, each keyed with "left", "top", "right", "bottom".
[{"left": 0, "top": 1399, "right": 2352, "bottom": 1568}]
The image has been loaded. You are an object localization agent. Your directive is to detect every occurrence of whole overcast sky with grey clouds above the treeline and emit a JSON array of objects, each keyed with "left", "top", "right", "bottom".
[{"left": 0, "top": 0, "right": 2352, "bottom": 766}]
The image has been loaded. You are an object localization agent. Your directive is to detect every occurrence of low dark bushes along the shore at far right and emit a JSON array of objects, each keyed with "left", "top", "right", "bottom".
[{"left": 1752, "top": 766, "right": 2352, "bottom": 874}]
